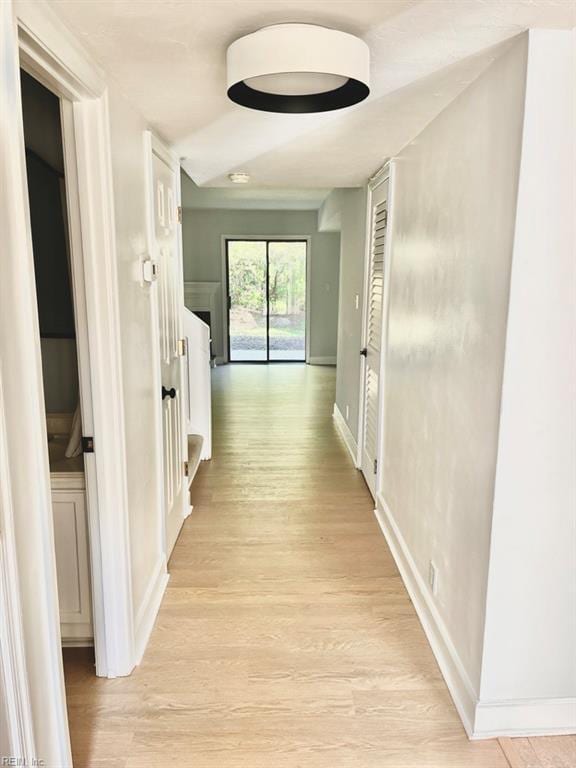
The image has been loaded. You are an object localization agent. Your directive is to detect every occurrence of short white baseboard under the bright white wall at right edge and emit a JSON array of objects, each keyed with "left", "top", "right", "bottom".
[{"left": 472, "top": 698, "right": 576, "bottom": 739}]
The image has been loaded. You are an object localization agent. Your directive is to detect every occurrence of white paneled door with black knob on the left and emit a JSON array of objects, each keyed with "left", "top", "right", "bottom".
[{"left": 152, "top": 152, "right": 187, "bottom": 557}]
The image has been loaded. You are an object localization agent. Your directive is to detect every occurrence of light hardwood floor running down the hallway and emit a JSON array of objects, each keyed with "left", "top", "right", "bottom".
[{"left": 66, "top": 365, "right": 576, "bottom": 768}]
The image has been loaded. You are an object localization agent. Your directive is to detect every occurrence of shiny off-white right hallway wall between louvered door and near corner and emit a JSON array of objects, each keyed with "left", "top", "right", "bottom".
[{"left": 381, "top": 37, "right": 526, "bottom": 694}]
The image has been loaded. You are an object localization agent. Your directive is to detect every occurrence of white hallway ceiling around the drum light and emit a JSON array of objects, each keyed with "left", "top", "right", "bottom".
[{"left": 51, "top": 0, "right": 576, "bottom": 189}]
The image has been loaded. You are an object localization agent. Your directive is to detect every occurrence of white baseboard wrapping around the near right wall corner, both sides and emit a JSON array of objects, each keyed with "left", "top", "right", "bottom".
[{"left": 375, "top": 493, "right": 576, "bottom": 739}]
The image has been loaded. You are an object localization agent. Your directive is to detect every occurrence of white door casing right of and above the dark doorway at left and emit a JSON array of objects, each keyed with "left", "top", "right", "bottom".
[{"left": 14, "top": 0, "right": 135, "bottom": 688}]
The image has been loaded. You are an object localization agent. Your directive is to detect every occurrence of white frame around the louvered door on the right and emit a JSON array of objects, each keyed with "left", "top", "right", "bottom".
[{"left": 356, "top": 158, "right": 395, "bottom": 500}]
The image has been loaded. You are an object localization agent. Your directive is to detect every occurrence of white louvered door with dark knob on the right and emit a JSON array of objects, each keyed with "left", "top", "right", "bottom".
[{"left": 361, "top": 179, "right": 388, "bottom": 496}]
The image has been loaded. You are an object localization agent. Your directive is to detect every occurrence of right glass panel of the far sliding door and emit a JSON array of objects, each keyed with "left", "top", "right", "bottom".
[{"left": 268, "top": 240, "right": 306, "bottom": 361}]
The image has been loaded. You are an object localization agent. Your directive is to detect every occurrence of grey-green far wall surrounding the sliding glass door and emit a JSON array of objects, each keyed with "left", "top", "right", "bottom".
[{"left": 182, "top": 208, "right": 340, "bottom": 361}]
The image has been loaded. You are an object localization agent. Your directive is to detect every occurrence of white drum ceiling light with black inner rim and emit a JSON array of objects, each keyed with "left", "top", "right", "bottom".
[{"left": 227, "top": 24, "right": 370, "bottom": 113}]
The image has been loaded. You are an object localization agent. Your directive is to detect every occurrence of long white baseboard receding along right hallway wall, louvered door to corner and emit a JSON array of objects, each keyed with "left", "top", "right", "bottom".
[{"left": 375, "top": 493, "right": 477, "bottom": 738}]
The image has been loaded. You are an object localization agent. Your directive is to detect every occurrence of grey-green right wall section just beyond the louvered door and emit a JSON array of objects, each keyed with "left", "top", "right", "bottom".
[{"left": 318, "top": 188, "right": 366, "bottom": 441}]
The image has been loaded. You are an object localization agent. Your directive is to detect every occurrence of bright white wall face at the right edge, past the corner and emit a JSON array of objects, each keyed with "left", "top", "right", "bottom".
[{"left": 481, "top": 30, "right": 576, "bottom": 712}]
